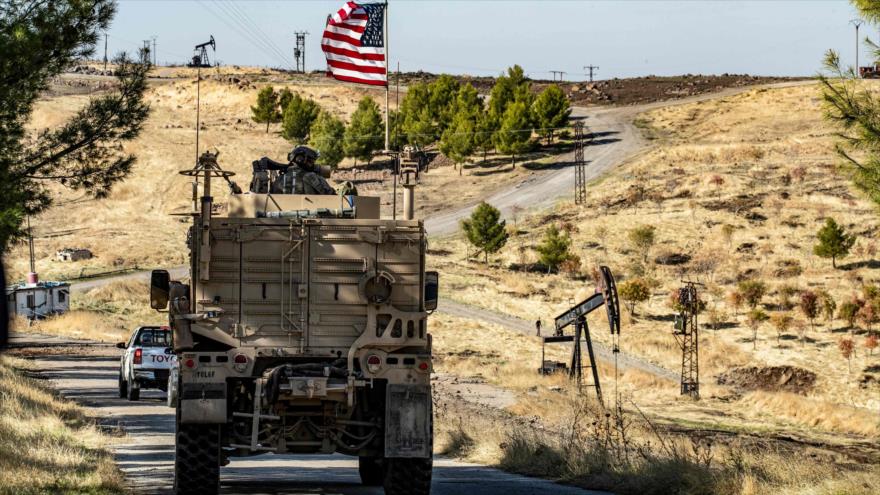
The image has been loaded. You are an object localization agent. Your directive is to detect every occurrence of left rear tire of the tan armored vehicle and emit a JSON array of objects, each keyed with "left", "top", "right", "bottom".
[{"left": 174, "top": 420, "right": 220, "bottom": 495}]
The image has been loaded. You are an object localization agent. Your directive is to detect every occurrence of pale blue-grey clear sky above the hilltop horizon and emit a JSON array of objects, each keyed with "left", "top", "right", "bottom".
[{"left": 108, "top": 0, "right": 878, "bottom": 80}]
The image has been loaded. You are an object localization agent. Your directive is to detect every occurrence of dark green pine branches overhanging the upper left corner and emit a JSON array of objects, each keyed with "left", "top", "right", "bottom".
[{"left": 0, "top": 0, "right": 149, "bottom": 251}]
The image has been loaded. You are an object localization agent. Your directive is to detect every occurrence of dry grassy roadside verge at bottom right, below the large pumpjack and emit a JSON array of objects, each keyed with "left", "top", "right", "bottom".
[{"left": 436, "top": 401, "right": 880, "bottom": 495}]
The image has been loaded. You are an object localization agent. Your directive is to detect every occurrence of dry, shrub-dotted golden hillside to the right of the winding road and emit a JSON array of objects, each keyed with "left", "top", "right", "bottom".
[{"left": 430, "top": 86, "right": 880, "bottom": 448}]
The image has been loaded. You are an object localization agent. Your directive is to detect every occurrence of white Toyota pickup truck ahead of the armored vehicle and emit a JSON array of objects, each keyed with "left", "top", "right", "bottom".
[{"left": 116, "top": 326, "right": 177, "bottom": 401}]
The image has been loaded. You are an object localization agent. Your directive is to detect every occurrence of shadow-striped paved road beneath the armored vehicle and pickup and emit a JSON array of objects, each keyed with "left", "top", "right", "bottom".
[{"left": 10, "top": 334, "right": 607, "bottom": 495}]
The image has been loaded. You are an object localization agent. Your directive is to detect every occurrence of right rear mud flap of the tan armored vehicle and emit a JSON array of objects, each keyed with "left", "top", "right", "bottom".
[{"left": 385, "top": 384, "right": 434, "bottom": 458}]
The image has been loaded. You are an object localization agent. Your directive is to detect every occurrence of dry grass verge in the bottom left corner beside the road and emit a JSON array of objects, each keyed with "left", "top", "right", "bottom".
[{"left": 0, "top": 356, "right": 124, "bottom": 495}]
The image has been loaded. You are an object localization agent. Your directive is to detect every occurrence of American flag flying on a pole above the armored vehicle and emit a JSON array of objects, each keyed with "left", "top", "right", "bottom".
[{"left": 321, "top": 2, "right": 388, "bottom": 86}]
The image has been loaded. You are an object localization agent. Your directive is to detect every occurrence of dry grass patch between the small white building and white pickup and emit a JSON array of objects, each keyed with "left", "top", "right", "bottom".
[{"left": 14, "top": 280, "right": 162, "bottom": 342}]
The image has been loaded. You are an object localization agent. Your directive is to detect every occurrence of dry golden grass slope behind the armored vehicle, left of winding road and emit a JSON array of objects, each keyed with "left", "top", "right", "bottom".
[{"left": 6, "top": 67, "right": 572, "bottom": 280}]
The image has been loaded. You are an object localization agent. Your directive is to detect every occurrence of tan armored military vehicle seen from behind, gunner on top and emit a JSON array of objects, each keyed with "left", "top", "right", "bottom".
[{"left": 150, "top": 153, "right": 438, "bottom": 495}]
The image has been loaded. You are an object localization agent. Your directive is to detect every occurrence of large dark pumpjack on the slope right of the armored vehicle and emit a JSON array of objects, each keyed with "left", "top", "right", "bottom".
[{"left": 541, "top": 266, "right": 620, "bottom": 405}]
